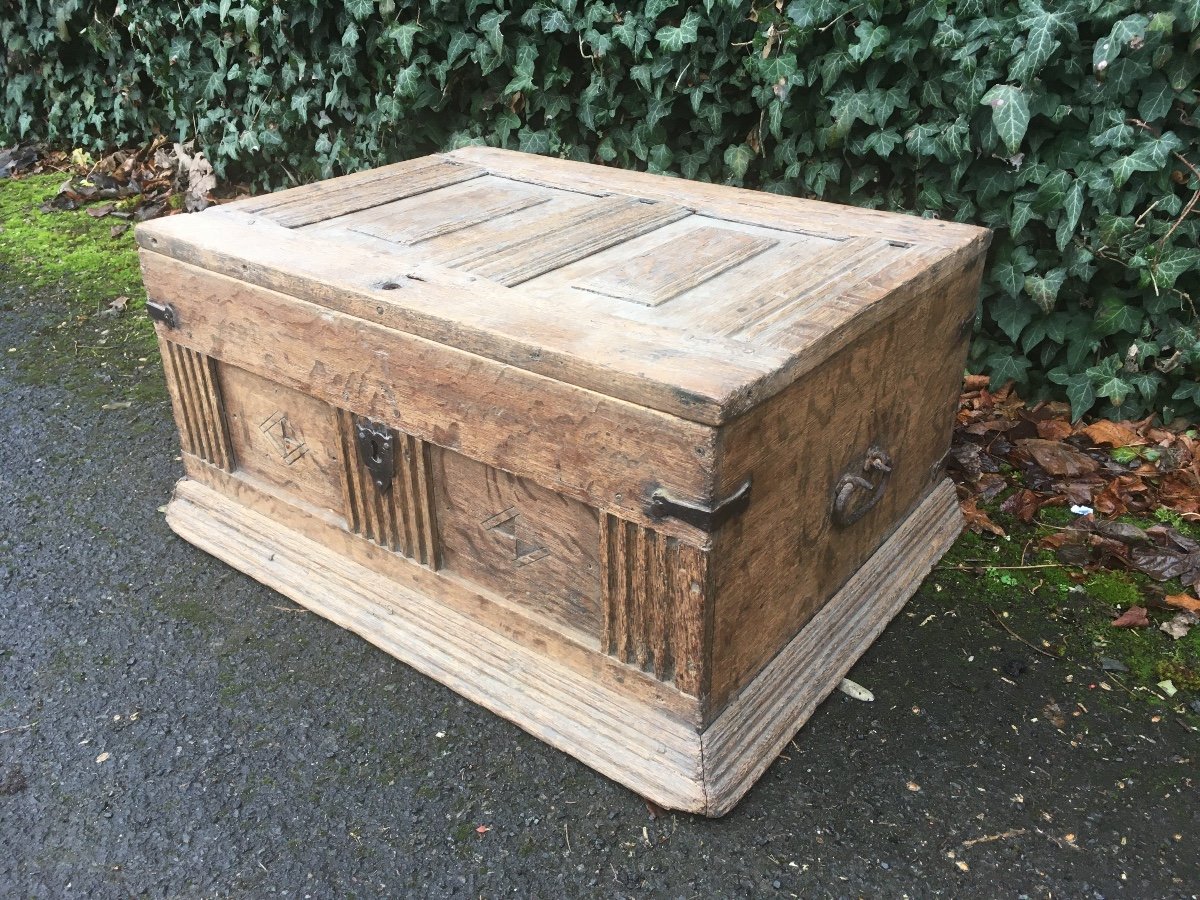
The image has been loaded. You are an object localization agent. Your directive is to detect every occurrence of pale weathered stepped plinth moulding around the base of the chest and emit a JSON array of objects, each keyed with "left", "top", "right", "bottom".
[{"left": 167, "top": 480, "right": 961, "bottom": 816}]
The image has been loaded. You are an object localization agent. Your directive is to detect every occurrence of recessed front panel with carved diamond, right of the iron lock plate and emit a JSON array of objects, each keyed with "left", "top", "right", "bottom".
[{"left": 434, "top": 450, "right": 600, "bottom": 643}]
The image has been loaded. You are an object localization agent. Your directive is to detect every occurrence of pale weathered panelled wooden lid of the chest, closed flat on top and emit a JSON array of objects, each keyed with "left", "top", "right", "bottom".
[{"left": 138, "top": 148, "right": 989, "bottom": 425}]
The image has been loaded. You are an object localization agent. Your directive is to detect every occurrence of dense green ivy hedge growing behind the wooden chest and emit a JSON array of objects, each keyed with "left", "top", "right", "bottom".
[{"left": 7, "top": 0, "right": 1200, "bottom": 419}]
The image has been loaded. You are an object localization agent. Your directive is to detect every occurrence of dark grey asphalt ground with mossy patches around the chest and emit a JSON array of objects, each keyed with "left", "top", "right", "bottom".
[{"left": 0, "top": 280, "right": 1200, "bottom": 898}]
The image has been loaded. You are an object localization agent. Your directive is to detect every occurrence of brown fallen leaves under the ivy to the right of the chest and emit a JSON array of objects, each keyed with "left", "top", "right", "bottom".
[{"left": 948, "top": 376, "right": 1200, "bottom": 637}]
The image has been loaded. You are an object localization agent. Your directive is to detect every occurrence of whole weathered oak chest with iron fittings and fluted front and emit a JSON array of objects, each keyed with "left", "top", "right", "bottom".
[{"left": 138, "top": 148, "right": 989, "bottom": 816}]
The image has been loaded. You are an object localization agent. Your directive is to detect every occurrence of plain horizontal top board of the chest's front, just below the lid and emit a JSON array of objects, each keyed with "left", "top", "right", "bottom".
[{"left": 143, "top": 253, "right": 716, "bottom": 544}]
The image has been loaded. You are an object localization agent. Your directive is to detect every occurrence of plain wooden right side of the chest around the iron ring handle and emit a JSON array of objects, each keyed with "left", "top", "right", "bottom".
[{"left": 710, "top": 250, "right": 982, "bottom": 714}]
